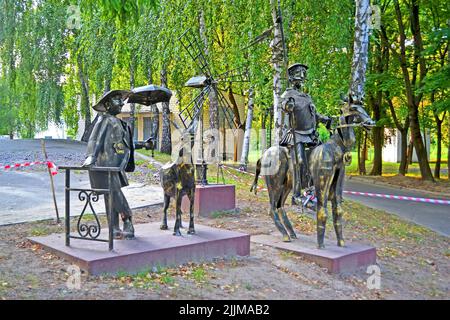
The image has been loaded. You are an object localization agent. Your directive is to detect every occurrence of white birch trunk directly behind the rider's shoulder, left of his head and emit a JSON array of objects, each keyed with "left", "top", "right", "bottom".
[{"left": 270, "top": 0, "right": 284, "bottom": 145}]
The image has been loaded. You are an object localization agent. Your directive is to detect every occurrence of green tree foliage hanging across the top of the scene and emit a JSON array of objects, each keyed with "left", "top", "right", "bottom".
[{"left": 0, "top": 0, "right": 450, "bottom": 152}]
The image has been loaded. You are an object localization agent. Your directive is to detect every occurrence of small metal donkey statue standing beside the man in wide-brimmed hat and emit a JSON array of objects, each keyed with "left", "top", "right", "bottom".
[{"left": 159, "top": 121, "right": 197, "bottom": 236}]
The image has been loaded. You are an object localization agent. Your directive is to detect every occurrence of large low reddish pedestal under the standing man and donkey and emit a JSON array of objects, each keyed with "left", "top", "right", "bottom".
[{"left": 29, "top": 221, "right": 250, "bottom": 275}]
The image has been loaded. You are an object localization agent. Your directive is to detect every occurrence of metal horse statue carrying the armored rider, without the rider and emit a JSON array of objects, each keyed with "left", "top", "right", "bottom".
[{"left": 250, "top": 102, "right": 374, "bottom": 248}]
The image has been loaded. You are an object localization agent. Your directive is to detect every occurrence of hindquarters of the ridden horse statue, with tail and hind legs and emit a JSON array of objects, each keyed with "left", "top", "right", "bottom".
[{"left": 250, "top": 146, "right": 297, "bottom": 242}]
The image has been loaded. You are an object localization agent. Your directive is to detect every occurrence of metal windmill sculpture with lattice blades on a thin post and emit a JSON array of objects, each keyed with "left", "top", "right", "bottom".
[{"left": 179, "top": 29, "right": 249, "bottom": 185}]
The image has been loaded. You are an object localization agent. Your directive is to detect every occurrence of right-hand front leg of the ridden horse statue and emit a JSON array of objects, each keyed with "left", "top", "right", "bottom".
[{"left": 330, "top": 168, "right": 345, "bottom": 247}]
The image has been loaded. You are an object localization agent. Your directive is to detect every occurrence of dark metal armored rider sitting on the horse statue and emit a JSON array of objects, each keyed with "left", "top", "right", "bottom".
[{"left": 280, "top": 63, "right": 331, "bottom": 204}]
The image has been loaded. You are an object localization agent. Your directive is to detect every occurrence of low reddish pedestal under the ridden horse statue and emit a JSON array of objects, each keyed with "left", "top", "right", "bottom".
[{"left": 252, "top": 233, "right": 377, "bottom": 273}]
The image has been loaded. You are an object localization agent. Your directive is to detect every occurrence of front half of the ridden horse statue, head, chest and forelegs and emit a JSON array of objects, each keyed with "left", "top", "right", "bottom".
[{"left": 309, "top": 101, "right": 375, "bottom": 248}]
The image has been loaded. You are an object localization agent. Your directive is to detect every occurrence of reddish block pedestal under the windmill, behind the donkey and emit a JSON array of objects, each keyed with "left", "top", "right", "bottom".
[{"left": 181, "top": 184, "right": 236, "bottom": 217}]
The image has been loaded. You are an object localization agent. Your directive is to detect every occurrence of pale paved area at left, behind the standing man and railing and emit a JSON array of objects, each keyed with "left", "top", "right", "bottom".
[{"left": 0, "top": 140, "right": 163, "bottom": 225}]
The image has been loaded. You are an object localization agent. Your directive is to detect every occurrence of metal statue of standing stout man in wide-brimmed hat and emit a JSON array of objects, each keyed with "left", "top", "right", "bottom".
[{"left": 83, "top": 90, "right": 134, "bottom": 239}]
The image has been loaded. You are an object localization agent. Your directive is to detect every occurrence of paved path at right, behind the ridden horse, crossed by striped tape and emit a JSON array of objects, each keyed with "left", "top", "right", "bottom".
[{"left": 344, "top": 179, "right": 450, "bottom": 237}]
